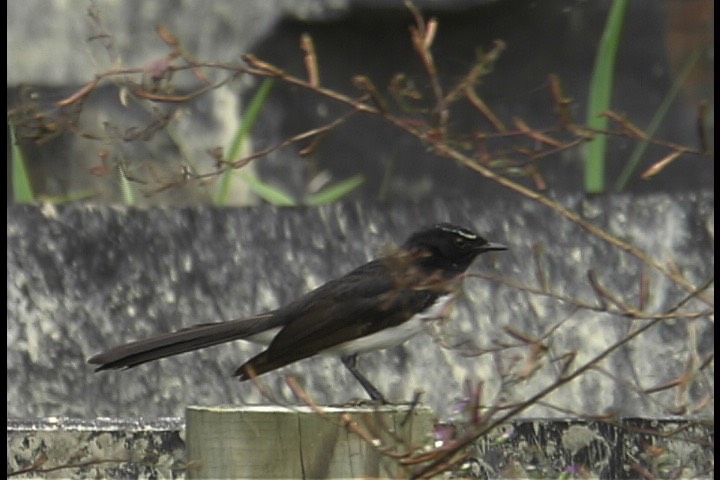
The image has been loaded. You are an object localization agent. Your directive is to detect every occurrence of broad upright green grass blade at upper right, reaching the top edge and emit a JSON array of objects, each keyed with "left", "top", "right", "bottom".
[{"left": 585, "top": 0, "right": 628, "bottom": 193}]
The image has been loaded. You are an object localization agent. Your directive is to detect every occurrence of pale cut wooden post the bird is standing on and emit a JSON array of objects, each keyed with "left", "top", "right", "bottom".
[{"left": 186, "top": 406, "right": 434, "bottom": 479}]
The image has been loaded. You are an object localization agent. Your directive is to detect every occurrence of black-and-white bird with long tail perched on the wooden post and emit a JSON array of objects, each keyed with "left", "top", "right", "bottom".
[{"left": 88, "top": 223, "right": 507, "bottom": 403}]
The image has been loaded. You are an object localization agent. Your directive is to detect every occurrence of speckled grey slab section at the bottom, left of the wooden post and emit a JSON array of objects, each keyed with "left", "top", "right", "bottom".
[{"left": 7, "top": 418, "right": 187, "bottom": 479}]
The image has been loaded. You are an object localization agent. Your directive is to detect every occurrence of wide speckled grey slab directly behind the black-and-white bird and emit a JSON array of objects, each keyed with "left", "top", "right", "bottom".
[{"left": 7, "top": 192, "right": 714, "bottom": 418}]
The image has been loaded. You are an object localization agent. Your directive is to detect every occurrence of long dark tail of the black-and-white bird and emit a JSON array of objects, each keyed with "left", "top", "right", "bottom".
[{"left": 88, "top": 313, "right": 273, "bottom": 371}]
